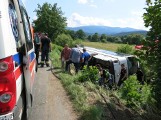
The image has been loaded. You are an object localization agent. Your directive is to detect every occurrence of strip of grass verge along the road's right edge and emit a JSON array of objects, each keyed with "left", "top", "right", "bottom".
[{"left": 50, "top": 45, "right": 107, "bottom": 120}]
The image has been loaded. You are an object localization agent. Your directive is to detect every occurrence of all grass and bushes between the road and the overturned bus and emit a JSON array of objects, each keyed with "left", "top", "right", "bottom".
[{"left": 51, "top": 45, "right": 160, "bottom": 120}]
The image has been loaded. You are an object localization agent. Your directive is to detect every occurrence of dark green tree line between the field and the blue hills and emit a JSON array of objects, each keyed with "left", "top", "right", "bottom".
[{"left": 67, "top": 29, "right": 145, "bottom": 45}]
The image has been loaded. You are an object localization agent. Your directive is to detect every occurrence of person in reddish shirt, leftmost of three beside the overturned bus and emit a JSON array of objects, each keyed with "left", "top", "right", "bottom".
[{"left": 60, "top": 44, "right": 71, "bottom": 71}]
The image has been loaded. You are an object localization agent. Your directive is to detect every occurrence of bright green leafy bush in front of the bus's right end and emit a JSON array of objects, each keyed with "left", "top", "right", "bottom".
[{"left": 119, "top": 75, "right": 152, "bottom": 107}]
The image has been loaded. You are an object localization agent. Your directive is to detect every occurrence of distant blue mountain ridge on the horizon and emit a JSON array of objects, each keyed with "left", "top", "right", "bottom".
[{"left": 67, "top": 26, "right": 147, "bottom": 36}]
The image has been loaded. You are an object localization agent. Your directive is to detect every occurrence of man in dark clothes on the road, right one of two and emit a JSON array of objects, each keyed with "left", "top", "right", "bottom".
[{"left": 40, "top": 34, "right": 51, "bottom": 67}]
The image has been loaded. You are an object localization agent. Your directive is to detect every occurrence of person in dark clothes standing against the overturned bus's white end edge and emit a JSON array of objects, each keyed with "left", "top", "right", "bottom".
[{"left": 117, "top": 64, "right": 127, "bottom": 87}]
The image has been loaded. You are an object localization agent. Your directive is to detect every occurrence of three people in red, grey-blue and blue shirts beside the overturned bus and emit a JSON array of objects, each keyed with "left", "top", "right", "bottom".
[{"left": 60, "top": 44, "right": 91, "bottom": 73}]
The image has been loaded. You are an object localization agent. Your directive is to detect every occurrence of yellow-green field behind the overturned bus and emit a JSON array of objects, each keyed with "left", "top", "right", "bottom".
[{"left": 82, "top": 42, "right": 134, "bottom": 51}]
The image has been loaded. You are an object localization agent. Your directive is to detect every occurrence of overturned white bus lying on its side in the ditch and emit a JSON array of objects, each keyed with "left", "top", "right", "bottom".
[{"left": 80, "top": 47, "right": 138, "bottom": 84}]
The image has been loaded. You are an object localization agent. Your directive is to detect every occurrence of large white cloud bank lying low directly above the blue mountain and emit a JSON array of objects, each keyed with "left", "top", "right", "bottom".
[{"left": 67, "top": 13, "right": 147, "bottom": 30}]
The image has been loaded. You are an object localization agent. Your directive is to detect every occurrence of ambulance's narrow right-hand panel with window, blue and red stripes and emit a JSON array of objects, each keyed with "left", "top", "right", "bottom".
[{"left": 15, "top": 0, "right": 36, "bottom": 113}]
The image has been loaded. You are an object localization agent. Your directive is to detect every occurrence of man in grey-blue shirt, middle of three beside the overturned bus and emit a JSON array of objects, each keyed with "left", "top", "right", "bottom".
[{"left": 66, "top": 45, "right": 81, "bottom": 73}]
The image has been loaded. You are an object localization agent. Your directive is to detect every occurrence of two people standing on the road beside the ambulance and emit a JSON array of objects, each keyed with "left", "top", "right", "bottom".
[{"left": 34, "top": 33, "right": 51, "bottom": 67}]
